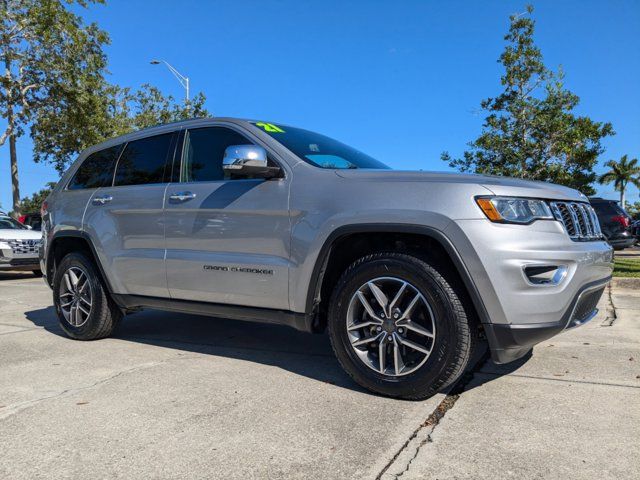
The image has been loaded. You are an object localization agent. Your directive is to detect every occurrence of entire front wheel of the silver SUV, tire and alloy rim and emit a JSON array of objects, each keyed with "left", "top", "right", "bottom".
[{"left": 328, "top": 252, "right": 473, "bottom": 400}]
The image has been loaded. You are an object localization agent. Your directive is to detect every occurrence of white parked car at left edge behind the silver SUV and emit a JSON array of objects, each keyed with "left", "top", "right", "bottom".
[{"left": 0, "top": 213, "right": 41, "bottom": 275}]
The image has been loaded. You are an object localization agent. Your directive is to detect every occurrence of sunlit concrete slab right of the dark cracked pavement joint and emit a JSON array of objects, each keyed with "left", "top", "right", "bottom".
[{"left": 384, "top": 282, "right": 640, "bottom": 479}]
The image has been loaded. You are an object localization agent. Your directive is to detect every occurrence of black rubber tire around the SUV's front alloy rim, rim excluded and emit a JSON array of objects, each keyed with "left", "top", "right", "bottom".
[{"left": 328, "top": 252, "right": 477, "bottom": 400}]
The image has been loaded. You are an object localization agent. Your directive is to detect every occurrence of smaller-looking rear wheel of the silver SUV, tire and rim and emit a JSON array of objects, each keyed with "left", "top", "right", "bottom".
[{"left": 53, "top": 253, "right": 122, "bottom": 340}]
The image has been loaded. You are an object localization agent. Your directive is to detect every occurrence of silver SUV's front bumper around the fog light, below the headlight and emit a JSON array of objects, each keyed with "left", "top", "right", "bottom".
[{"left": 448, "top": 219, "right": 613, "bottom": 363}]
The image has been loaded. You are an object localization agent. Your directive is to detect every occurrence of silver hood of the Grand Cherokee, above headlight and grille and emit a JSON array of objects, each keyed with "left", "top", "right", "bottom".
[{"left": 335, "top": 169, "right": 588, "bottom": 202}]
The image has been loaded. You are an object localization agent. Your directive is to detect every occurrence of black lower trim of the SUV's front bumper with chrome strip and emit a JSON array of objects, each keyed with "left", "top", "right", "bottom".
[{"left": 484, "top": 278, "right": 610, "bottom": 363}]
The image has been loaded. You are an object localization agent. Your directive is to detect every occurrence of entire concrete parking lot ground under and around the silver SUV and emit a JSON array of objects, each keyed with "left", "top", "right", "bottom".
[{"left": 0, "top": 273, "right": 640, "bottom": 479}]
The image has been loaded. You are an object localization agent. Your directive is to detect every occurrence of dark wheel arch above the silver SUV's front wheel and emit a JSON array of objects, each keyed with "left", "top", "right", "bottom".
[{"left": 305, "top": 223, "right": 490, "bottom": 332}]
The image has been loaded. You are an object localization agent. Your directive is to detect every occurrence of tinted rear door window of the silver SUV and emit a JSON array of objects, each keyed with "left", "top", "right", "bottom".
[{"left": 114, "top": 133, "right": 173, "bottom": 186}]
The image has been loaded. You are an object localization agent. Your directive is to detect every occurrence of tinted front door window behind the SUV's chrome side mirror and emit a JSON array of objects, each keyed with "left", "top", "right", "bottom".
[{"left": 182, "top": 127, "right": 268, "bottom": 182}]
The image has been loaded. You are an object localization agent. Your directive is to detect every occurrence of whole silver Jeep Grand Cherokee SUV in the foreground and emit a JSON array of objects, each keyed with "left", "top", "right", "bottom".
[{"left": 41, "top": 118, "right": 612, "bottom": 399}]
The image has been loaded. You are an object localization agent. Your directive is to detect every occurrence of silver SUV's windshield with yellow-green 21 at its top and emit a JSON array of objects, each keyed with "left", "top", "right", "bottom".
[{"left": 253, "top": 122, "right": 389, "bottom": 169}]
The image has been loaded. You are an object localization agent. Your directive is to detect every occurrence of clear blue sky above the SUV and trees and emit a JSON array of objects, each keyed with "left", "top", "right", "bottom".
[{"left": 0, "top": 0, "right": 640, "bottom": 209}]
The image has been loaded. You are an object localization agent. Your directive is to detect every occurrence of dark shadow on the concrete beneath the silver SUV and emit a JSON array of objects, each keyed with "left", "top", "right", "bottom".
[{"left": 26, "top": 307, "right": 529, "bottom": 395}]
